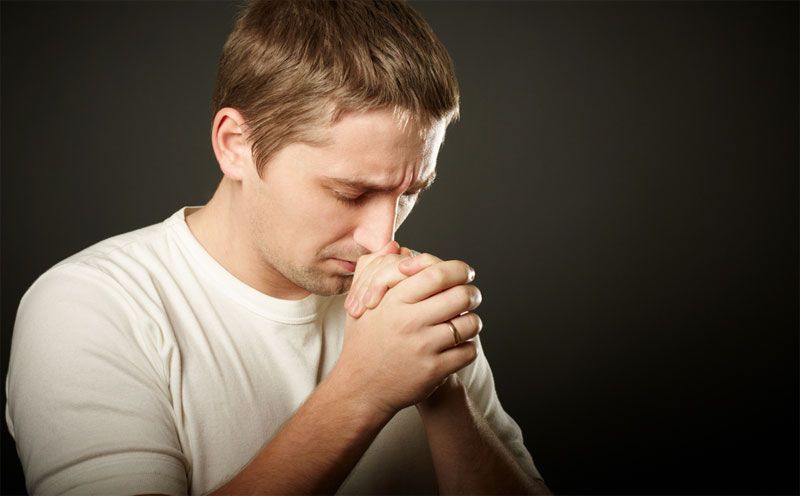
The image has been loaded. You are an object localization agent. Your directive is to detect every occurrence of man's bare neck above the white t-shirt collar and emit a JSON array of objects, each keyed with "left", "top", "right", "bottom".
[{"left": 186, "top": 177, "right": 309, "bottom": 300}]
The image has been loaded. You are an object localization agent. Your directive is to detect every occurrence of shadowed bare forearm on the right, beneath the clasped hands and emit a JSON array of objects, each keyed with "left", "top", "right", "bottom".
[{"left": 418, "top": 376, "right": 552, "bottom": 494}]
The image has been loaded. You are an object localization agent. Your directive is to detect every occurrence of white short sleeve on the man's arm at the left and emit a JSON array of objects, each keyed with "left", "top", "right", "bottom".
[{"left": 6, "top": 263, "right": 188, "bottom": 494}]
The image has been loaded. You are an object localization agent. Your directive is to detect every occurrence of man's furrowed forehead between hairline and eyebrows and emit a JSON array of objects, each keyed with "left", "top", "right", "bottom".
[{"left": 303, "top": 110, "right": 446, "bottom": 189}]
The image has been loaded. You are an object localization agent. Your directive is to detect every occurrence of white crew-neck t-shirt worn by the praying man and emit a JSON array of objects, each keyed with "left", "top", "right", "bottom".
[{"left": 6, "top": 207, "right": 539, "bottom": 494}]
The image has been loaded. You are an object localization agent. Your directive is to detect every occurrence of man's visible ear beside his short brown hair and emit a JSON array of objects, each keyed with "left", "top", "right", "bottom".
[{"left": 211, "top": 107, "right": 252, "bottom": 181}]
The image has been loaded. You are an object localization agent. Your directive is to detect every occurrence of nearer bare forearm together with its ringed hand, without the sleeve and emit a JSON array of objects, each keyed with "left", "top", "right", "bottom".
[{"left": 209, "top": 242, "right": 476, "bottom": 494}]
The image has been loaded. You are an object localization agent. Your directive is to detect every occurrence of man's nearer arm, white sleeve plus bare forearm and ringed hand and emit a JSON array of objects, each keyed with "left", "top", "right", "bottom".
[{"left": 7, "top": 245, "right": 476, "bottom": 494}]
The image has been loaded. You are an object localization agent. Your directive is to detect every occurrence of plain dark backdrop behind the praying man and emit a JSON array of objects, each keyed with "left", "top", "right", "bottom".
[{"left": 0, "top": 2, "right": 800, "bottom": 494}]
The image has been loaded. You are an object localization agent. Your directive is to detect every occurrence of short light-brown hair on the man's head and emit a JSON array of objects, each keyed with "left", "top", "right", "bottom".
[{"left": 212, "top": 0, "right": 459, "bottom": 173}]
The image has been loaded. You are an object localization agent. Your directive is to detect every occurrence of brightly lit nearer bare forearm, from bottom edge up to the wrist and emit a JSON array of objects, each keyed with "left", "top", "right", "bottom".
[{"left": 213, "top": 374, "right": 391, "bottom": 494}]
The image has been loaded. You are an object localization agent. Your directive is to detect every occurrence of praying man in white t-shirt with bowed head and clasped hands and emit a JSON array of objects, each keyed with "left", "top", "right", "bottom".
[{"left": 6, "top": 1, "right": 548, "bottom": 494}]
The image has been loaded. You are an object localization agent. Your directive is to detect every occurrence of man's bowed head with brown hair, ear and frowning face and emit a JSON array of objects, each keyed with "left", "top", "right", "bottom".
[{"left": 212, "top": 0, "right": 458, "bottom": 297}]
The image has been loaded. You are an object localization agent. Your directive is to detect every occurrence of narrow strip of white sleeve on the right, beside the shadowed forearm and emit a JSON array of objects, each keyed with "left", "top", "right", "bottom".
[{"left": 458, "top": 337, "right": 542, "bottom": 479}]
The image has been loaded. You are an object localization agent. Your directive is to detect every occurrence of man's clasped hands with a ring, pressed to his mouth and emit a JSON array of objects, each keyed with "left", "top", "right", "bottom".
[{"left": 337, "top": 241, "right": 482, "bottom": 414}]
